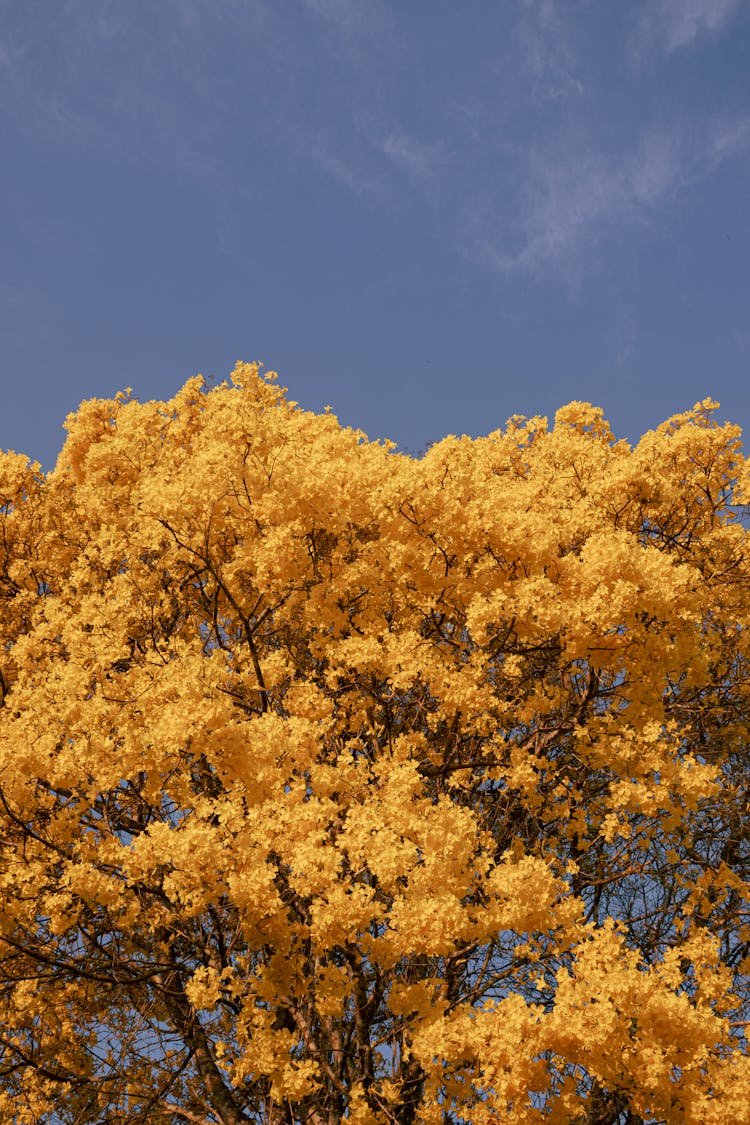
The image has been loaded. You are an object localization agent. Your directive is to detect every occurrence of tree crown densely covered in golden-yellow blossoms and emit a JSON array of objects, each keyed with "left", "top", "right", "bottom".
[{"left": 0, "top": 365, "right": 750, "bottom": 1125}]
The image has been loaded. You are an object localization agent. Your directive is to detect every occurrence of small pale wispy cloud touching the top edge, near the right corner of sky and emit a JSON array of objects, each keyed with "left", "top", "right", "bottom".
[{"left": 633, "top": 0, "right": 743, "bottom": 61}]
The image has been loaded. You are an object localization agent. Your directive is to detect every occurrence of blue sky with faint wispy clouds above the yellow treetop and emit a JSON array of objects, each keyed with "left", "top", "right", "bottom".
[{"left": 0, "top": 0, "right": 750, "bottom": 467}]
